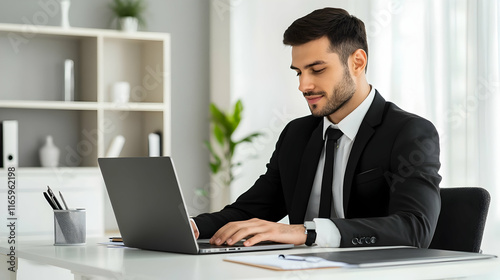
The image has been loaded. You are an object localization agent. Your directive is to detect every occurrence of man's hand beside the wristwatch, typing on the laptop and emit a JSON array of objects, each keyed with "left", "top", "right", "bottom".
[{"left": 210, "top": 218, "right": 307, "bottom": 246}]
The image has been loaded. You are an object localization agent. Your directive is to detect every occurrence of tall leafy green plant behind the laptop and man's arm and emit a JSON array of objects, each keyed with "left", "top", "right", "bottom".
[{"left": 200, "top": 100, "right": 262, "bottom": 211}]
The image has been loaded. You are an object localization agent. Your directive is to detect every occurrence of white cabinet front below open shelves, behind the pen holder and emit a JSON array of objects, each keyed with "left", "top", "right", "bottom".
[{"left": 0, "top": 167, "right": 105, "bottom": 237}]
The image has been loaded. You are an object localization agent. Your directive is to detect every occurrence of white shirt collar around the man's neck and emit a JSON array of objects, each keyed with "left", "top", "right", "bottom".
[{"left": 323, "top": 86, "right": 375, "bottom": 141}]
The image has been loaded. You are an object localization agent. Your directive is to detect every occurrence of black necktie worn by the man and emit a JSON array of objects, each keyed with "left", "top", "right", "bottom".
[{"left": 318, "top": 127, "right": 343, "bottom": 218}]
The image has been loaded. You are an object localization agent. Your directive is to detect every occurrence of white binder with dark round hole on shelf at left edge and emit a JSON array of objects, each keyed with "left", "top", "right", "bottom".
[{"left": 0, "top": 120, "right": 19, "bottom": 167}]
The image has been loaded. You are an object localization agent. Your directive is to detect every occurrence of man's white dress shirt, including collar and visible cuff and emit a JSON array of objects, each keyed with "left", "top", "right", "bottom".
[{"left": 305, "top": 87, "right": 375, "bottom": 247}]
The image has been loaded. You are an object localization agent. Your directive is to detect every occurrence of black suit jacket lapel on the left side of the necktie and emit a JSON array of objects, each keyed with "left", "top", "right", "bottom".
[{"left": 289, "top": 121, "right": 324, "bottom": 224}]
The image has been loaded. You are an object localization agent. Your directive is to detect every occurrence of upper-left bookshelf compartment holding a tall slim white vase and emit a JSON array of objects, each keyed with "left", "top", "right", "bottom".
[{"left": 0, "top": 31, "right": 97, "bottom": 102}]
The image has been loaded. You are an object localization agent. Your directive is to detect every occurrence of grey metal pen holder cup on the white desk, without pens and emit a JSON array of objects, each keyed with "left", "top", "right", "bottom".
[{"left": 54, "top": 209, "right": 87, "bottom": 245}]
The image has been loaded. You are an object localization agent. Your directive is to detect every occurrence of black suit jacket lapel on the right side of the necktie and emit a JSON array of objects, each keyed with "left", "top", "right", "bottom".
[{"left": 343, "top": 90, "right": 385, "bottom": 212}]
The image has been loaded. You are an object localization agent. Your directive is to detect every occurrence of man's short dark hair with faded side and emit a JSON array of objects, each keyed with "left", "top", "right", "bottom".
[{"left": 283, "top": 8, "right": 368, "bottom": 71}]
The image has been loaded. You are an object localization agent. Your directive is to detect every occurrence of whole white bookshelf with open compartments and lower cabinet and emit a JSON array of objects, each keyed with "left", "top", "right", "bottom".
[{"left": 0, "top": 24, "right": 171, "bottom": 237}]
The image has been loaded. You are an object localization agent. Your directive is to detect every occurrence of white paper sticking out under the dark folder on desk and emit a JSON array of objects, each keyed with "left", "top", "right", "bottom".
[{"left": 224, "top": 255, "right": 353, "bottom": 270}]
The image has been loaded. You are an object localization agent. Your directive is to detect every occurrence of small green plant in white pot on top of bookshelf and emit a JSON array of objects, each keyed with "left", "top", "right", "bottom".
[{"left": 110, "top": 0, "right": 146, "bottom": 32}]
